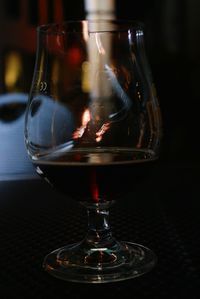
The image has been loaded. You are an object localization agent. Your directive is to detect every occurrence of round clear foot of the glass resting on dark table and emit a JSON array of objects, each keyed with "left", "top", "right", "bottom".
[{"left": 43, "top": 242, "right": 157, "bottom": 283}]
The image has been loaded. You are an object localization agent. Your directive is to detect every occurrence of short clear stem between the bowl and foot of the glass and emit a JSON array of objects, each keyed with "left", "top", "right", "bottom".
[{"left": 85, "top": 205, "right": 114, "bottom": 248}]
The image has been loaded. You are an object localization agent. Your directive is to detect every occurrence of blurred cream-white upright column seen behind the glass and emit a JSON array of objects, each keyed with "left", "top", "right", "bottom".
[{"left": 84, "top": 0, "right": 115, "bottom": 102}]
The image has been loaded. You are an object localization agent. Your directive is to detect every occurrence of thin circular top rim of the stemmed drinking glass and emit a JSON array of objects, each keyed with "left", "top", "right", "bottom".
[{"left": 36, "top": 19, "right": 144, "bottom": 35}]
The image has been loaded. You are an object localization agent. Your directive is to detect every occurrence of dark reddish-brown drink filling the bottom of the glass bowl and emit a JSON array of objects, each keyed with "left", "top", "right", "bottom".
[{"left": 34, "top": 150, "right": 155, "bottom": 203}]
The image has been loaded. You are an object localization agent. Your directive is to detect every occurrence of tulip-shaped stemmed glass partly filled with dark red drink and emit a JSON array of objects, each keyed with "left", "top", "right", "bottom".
[{"left": 25, "top": 20, "right": 162, "bottom": 283}]
